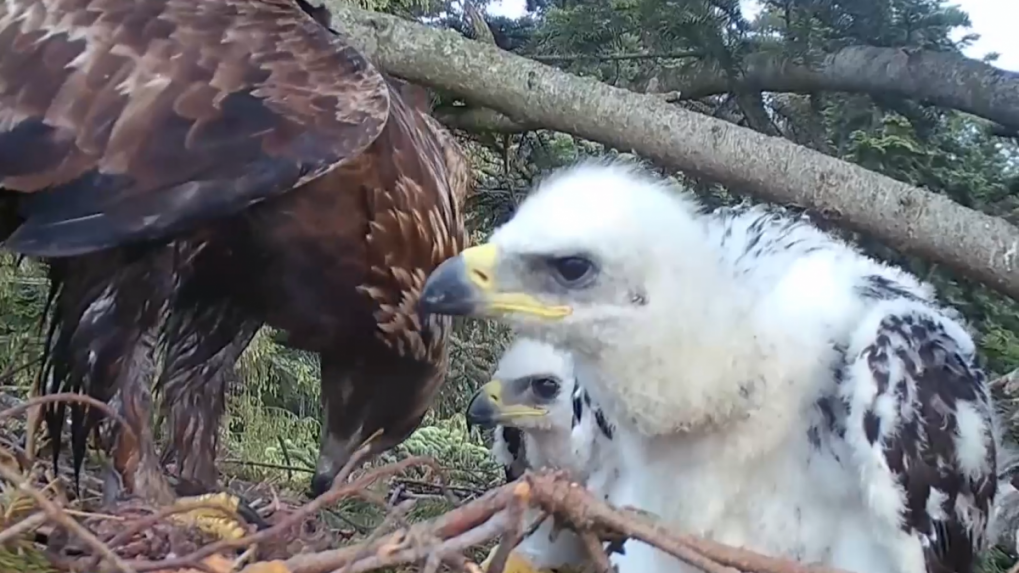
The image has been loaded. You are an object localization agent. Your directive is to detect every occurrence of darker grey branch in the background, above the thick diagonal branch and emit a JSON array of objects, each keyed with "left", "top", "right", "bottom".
[{"left": 658, "top": 46, "right": 1019, "bottom": 131}]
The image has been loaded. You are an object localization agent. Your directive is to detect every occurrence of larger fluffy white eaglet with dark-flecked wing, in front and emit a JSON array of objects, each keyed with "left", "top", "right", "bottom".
[{"left": 419, "top": 157, "right": 998, "bottom": 573}]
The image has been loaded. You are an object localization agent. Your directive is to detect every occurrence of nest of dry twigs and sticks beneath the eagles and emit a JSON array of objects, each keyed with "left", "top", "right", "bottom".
[{"left": 0, "top": 383, "right": 1019, "bottom": 573}]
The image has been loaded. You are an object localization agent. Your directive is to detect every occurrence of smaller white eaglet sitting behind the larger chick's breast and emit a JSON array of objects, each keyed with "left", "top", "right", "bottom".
[{"left": 467, "top": 337, "right": 613, "bottom": 573}]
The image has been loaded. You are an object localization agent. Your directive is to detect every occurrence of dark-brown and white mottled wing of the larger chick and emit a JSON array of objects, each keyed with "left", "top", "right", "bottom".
[{"left": 842, "top": 291, "right": 997, "bottom": 573}]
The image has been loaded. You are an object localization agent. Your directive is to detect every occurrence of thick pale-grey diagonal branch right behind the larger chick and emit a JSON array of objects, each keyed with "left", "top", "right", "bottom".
[{"left": 331, "top": 3, "right": 1019, "bottom": 299}]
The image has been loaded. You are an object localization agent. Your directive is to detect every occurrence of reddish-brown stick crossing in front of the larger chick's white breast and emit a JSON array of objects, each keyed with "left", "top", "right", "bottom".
[{"left": 523, "top": 472, "right": 847, "bottom": 573}]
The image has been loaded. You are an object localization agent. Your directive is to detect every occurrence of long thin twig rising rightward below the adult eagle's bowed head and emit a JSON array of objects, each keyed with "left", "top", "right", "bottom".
[{"left": 131, "top": 447, "right": 435, "bottom": 573}]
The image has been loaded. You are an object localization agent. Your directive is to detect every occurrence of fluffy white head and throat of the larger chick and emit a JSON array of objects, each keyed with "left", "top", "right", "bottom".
[{"left": 419, "top": 161, "right": 762, "bottom": 433}]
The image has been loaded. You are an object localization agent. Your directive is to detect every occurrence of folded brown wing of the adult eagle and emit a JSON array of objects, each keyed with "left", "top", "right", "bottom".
[{"left": 0, "top": 0, "right": 389, "bottom": 257}]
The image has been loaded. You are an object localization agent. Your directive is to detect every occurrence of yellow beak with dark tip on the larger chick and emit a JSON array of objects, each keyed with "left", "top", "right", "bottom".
[{"left": 418, "top": 244, "right": 571, "bottom": 319}]
